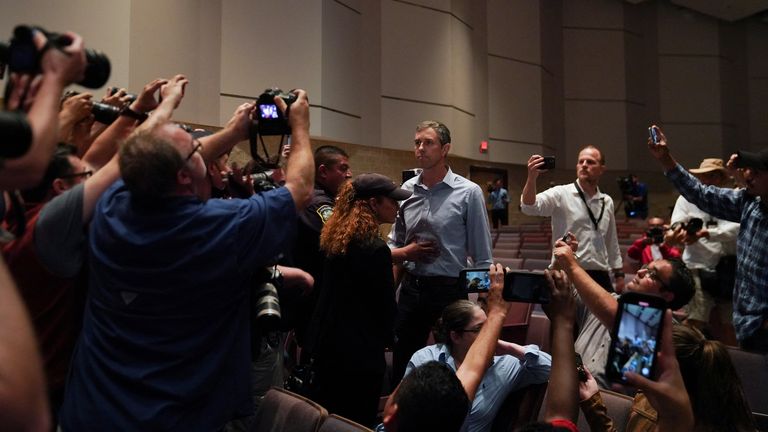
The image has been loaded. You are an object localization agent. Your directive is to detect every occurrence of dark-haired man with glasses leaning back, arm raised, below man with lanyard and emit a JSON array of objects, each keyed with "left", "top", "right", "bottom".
[{"left": 554, "top": 240, "right": 694, "bottom": 389}]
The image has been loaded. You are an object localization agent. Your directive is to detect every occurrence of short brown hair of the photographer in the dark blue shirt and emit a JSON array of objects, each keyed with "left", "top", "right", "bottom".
[{"left": 120, "top": 129, "right": 184, "bottom": 200}]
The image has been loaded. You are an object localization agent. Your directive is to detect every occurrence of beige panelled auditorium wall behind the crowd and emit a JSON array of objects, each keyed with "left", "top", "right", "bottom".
[{"left": 0, "top": 0, "right": 768, "bottom": 172}]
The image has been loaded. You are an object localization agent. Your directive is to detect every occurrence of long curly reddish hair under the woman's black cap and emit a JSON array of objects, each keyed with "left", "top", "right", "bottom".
[{"left": 320, "top": 181, "right": 380, "bottom": 255}]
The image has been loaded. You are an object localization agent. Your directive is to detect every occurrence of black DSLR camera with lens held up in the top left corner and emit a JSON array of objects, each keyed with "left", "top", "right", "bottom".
[{"left": 0, "top": 25, "right": 112, "bottom": 88}]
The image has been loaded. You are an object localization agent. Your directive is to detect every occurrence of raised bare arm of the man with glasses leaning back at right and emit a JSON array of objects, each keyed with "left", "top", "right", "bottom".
[{"left": 553, "top": 240, "right": 619, "bottom": 329}]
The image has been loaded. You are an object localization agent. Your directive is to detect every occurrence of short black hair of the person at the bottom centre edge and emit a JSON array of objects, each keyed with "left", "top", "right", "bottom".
[{"left": 393, "top": 361, "right": 470, "bottom": 432}]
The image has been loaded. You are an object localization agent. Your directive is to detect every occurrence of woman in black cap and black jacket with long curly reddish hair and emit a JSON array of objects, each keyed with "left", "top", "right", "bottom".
[{"left": 310, "top": 174, "right": 411, "bottom": 426}]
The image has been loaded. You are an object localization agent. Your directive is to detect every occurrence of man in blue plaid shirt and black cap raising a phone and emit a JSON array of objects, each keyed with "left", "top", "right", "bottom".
[{"left": 648, "top": 126, "right": 768, "bottom": 353}]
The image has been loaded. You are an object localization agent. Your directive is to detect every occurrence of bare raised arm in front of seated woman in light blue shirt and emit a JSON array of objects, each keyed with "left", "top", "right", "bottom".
[{"left": 456, "top": 264, "right": 509, "bottom": 401}]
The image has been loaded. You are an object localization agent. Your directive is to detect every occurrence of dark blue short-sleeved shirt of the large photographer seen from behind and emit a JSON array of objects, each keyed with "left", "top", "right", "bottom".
[{"left": 60, "top": 181, "right": 296, "bottom": 431}]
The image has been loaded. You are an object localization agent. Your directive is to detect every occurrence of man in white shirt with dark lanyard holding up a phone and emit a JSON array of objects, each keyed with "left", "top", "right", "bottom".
[{"left": 520, "top": 146, "right": 624, "bottom": 293}]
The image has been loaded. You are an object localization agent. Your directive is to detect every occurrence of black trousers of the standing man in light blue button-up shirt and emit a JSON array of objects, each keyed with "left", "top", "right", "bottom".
[{"left": 392, "top": 273, "right": 467, "bottom": 387}]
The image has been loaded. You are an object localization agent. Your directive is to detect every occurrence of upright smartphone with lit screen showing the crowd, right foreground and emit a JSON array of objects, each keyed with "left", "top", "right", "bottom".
[{"left": 606, "top": 293, "right": 665, "bottom": 382}]
